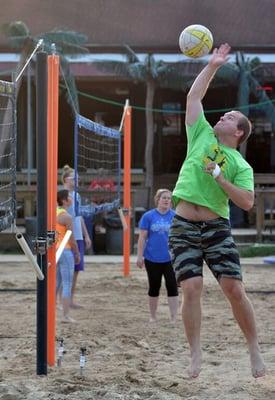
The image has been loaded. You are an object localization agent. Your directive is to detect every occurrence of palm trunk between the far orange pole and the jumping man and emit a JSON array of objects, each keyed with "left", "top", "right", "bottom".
[{"left": 145, "top": 79, "right": 155, "bottom": 205}]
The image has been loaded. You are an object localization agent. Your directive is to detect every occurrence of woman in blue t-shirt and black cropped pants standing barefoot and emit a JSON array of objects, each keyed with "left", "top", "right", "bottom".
[{"left": 137, "top": 189, "right": 178, "bottom": 323}]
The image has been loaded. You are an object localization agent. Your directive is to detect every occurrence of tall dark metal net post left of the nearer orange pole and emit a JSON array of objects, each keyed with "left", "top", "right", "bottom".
[{"left": 36, "top": 51, "right": 48, "bottom": 375}]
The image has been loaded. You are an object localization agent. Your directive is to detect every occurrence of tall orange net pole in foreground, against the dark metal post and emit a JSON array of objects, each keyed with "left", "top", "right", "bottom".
[{"left": 47, "top": 55, "right": 59, "bottom": 366}]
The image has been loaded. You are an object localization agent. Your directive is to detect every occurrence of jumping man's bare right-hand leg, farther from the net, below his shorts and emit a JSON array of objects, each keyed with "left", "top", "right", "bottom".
[{"left": 220, "top": 278, "right": 266, "bottom": 378}]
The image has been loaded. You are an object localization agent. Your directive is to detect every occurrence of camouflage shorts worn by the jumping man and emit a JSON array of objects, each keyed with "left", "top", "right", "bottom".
[{"left": 169, "top": 215, "right": 242, "bottom": 284}]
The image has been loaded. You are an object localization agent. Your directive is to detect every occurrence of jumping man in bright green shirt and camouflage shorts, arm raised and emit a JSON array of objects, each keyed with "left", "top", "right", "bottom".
[{"left": 169, "top": 44, "right": 265, "bottom": 378}]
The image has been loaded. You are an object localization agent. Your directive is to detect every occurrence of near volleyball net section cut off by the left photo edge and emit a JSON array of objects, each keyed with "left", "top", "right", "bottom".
[{"left": 0, "top": 81, "right": 16, "bottom": 232}]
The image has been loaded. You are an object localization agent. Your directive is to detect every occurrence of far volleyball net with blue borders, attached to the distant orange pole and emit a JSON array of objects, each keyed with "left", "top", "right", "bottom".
[{"left": 74, "top": 114, "right": 121, "bottom": 217}]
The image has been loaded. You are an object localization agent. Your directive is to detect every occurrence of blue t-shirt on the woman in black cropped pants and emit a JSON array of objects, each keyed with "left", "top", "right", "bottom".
[{"left": 139, "top": 208, "right": 175, "bottom": 263}]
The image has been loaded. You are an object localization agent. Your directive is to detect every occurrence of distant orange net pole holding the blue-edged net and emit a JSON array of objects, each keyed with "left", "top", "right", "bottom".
[{"left": 123, "top": 107, "right": 132, "bottom": 276}]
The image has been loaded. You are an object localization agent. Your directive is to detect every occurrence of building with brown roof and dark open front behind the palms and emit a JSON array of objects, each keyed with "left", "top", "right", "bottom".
[{"left": 0, "top": 0, "right": 275, "bottom": 183}]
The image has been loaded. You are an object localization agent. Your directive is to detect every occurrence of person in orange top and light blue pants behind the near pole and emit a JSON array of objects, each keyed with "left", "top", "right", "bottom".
[{"left": 56, "top": 190, "right": 80, "bottom": 323}]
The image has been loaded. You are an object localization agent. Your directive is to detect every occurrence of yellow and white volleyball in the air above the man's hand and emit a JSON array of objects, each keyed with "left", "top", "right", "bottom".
[{"left": 179, "top": 25, "right": 213, "bottom": 58}]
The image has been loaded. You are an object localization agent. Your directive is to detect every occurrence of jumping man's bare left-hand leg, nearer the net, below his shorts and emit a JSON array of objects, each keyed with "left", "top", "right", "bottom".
[{"left": 181, "top": 277, "right": 203, "bottom": 378}]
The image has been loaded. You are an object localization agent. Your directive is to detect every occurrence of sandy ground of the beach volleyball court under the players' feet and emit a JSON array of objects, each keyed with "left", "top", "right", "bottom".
[{"left": 0, "top": 263, "right": 275, "bottom": 400}]
